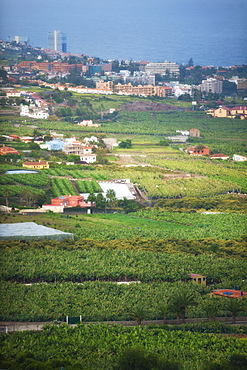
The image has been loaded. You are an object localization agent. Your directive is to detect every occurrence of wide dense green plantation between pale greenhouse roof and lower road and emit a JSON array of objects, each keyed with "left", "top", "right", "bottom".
[{"left": 0, "top": 239, "right": 247, "bottom": 321}]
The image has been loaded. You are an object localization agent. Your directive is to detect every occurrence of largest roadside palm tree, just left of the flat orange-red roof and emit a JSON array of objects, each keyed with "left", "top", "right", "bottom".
[{"left": 169, "top": 289, "right": 198, "bottom": 323}]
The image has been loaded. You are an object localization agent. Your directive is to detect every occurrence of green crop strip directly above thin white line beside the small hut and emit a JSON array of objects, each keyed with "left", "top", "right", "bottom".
[{"left": 0, "top": 246, "right": 247, "bottom": 290}]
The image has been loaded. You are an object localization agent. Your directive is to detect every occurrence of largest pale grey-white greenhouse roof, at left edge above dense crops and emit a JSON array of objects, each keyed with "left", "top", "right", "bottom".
[{"left": 0, "top": 222, "right": 74, "bottom": 240}]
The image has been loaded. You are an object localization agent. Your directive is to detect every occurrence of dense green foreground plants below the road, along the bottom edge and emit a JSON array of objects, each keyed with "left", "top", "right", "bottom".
[{"left": 1, "top": 325, "right": 246, "bottom": 370}]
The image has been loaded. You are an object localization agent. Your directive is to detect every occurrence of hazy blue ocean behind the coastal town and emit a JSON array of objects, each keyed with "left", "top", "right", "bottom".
[{"left": 0, "top": 0, "right": 247, "bottom": 66}]
